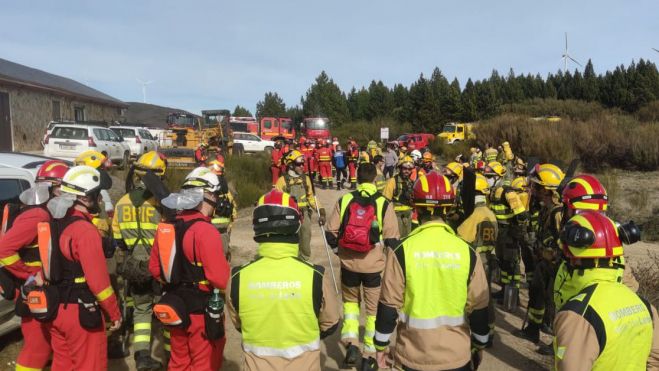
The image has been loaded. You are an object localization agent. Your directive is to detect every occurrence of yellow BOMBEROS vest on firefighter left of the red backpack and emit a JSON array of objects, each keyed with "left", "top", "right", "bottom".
[{"left": 231, "top": 243, "right": 323, "bottom": 359}]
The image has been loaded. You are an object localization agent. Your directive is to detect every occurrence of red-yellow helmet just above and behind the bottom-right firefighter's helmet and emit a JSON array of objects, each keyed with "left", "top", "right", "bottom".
[{"left": 563, "top": 174, "right": 609, "bottom": 211}]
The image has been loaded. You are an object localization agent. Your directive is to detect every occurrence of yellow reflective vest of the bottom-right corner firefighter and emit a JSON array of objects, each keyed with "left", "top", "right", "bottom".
[{"left": 555, "top": 282, "right": 653, "bottom": 371}]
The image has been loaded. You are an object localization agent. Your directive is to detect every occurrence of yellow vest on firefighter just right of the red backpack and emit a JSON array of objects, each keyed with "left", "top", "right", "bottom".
[{"left": 394, "top": 222, "right": 476, "bottom": 329}]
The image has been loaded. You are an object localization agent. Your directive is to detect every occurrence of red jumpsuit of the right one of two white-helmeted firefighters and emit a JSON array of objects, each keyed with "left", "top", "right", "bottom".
[{"left": 149, "top": 210, "right": 230, "bottom": 371}]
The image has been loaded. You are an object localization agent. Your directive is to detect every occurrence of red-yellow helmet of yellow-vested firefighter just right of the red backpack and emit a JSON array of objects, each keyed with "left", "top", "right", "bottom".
[{"left": 413, "top": 171, "right": 455, "bottom": 208}]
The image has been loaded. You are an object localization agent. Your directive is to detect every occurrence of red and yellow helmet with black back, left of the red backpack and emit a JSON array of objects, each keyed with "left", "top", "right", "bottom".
[{"left": 252, "top": 189, "right": 302, "bottom": 242}]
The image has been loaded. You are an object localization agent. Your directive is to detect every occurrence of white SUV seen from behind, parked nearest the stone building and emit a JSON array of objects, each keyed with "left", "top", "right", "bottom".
[{"left": 44, "top": 123, "right": 130, "bottom": 168}]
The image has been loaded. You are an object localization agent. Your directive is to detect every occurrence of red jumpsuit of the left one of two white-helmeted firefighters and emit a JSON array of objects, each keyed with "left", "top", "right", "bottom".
[{"left": 46, "top": 209, "right": 121, "bottom": 371}]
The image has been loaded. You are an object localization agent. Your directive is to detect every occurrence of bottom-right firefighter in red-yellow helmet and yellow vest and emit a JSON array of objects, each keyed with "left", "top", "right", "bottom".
[{"left": 554, "top": 210, "right": 659, "bottom": 371}]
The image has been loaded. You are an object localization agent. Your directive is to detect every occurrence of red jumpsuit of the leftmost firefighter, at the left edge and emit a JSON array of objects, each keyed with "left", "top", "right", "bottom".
[{"left": 0, "top": 207, "right": 51, "bottom": 369}]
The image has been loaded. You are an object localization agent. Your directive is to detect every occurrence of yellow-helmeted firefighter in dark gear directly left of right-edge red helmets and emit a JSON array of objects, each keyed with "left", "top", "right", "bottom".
[{"left": 515, "top": 164, "right": 565, "bottom": 354}]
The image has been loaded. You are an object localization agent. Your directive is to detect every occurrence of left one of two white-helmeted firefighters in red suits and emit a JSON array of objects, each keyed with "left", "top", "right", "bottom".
[{"left": 36, "top": 165, "right": 122, "bottom": 370}]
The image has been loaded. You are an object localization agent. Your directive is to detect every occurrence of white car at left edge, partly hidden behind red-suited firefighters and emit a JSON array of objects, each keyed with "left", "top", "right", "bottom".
[{"left": 0, "top": 152, "right": 73, "bottom": 336}]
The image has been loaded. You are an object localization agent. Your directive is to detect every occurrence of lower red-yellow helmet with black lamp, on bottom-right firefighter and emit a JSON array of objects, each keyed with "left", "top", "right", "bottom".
[{"left": 560, "top": 210, "right": 623, "bottom": 259}]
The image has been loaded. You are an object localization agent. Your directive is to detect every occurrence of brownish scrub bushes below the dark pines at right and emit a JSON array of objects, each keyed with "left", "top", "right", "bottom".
[{"left": 474, "top": 112, "right": 659, "bottom": 171}]
